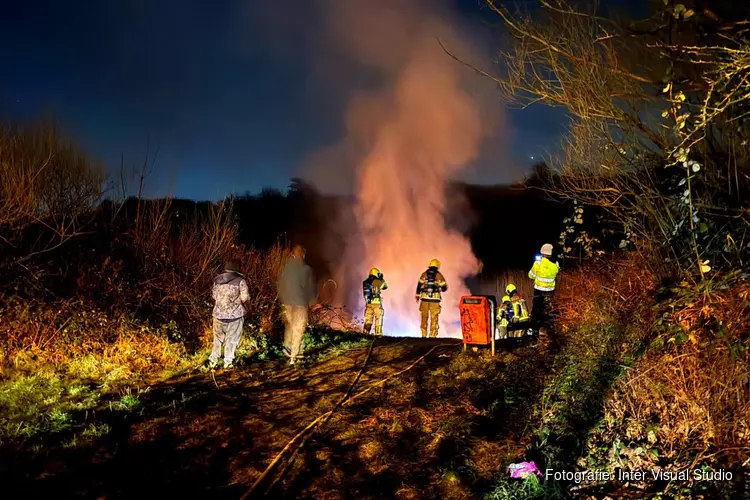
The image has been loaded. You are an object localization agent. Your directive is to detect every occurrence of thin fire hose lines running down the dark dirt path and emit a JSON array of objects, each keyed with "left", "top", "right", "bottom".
[{"left": 240, "top": 339, "right": 458, "bottom": 500}]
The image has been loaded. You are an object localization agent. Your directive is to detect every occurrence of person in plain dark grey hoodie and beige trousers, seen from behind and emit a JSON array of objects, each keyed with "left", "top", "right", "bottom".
[{"left": 279, "top": 245, "right": 318, "bottom": 365}]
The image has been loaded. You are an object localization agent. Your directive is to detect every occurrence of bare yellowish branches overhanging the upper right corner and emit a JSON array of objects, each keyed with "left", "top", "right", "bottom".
[{"left": 483, "top": 0, "right": 750, "bottom": 277}]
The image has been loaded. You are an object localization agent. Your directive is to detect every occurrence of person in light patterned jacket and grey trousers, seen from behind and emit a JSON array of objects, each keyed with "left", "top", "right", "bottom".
[{"left": 208, "top": 261, "right": 250, "bottom": 368}]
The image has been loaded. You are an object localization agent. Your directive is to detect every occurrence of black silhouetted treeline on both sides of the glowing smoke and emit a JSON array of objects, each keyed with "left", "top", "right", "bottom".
[{"left": 220, "top": 180, "right": 565, "bottom": 274}]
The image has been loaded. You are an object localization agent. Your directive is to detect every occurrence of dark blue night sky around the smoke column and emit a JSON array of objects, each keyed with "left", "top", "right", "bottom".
[{"left": 0, "top": 0, "right": 588, "bottom": 199}]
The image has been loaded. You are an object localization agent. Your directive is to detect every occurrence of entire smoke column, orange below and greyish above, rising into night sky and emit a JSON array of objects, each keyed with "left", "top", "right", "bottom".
[{"left": 250, "top": 0, "right": 516, "bottom": 337}]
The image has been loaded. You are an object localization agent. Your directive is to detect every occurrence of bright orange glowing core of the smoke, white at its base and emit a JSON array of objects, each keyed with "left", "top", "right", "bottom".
[{"left": 355, "top": 51, "right": 488, "bottom": 336}]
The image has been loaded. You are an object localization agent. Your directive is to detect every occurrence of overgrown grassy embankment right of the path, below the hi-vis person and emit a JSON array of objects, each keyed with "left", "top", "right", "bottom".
[{"left": 482, "top": 257, "right": 750, "bottom": 499}]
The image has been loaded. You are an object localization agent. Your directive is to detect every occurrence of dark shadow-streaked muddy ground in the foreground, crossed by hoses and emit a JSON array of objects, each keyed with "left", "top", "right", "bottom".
[{"left": 0, "top": 338, "right": 542, "bottom": 499}]
